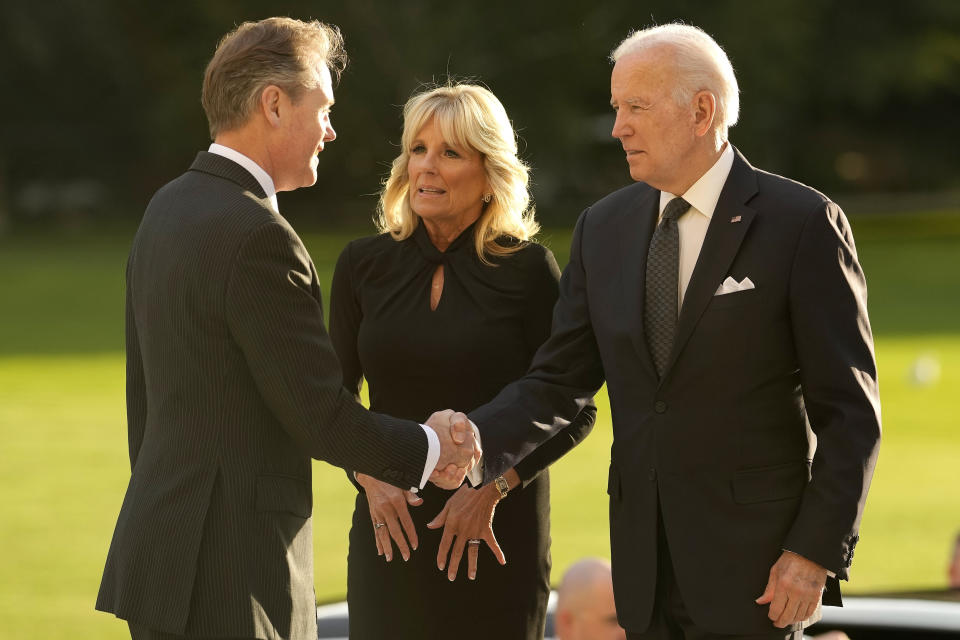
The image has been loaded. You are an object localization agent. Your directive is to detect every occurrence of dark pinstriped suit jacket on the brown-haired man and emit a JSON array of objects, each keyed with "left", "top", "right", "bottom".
[{"left": 97, "top": 152, "right": 427, "bottom": 640}]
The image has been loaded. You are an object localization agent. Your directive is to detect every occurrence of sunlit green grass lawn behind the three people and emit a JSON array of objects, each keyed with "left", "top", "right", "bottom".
[{"left": 0, "top": 212, "right": 960, "bottom": 639}]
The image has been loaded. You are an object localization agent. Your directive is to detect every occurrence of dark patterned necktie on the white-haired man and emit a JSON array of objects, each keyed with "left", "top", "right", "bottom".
[{"left": 643, "top": 198, "right": 690, "bottom": 377}]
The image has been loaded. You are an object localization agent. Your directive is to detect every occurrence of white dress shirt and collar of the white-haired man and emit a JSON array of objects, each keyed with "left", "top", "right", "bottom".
[{"left": 657, "top": 142, "right": 733, "bottom": 311}]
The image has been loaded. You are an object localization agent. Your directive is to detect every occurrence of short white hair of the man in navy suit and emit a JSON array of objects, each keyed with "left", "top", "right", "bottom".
[{"left": 610, "top": 23, "right": 740, "bottom": 141}]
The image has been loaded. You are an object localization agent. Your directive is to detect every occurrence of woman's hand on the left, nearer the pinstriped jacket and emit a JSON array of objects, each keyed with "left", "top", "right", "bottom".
[{"left": 356, "top": 473, "right": 423, "bottom": 562}]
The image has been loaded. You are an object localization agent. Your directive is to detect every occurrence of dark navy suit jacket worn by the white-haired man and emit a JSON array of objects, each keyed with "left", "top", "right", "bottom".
[{"left": 471, "top": 151, "right": 880, "bottom": 634}]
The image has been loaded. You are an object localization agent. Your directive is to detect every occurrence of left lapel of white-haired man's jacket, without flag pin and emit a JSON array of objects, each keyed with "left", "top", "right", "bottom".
[{"left": 618, "top": 189, "right": 660, "bottom": 378}]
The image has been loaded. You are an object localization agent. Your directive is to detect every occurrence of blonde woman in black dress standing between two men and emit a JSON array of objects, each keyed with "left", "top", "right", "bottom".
[{"left": 330, "top": 84, "right": 595, "bottom": 640}]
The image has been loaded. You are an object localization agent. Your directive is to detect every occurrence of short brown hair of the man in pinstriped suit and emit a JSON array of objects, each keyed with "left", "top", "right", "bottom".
[{"left": 201, "top": 18, "right": 347, "bottom": 138}]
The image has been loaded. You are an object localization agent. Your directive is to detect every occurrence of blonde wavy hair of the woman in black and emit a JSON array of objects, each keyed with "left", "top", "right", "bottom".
[{"left": 376, "top": 84, "right": 540, "bottom": 264}]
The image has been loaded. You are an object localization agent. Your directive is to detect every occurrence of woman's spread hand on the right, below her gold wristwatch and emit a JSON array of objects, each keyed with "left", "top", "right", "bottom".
[{"left": 427, "top": 484, "right": 507, "bottom": 582}]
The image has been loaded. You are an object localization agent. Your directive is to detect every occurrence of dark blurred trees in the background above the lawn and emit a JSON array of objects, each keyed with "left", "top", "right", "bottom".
[{"left": 0, "top": 0, "right": 960, "bottom": 229}]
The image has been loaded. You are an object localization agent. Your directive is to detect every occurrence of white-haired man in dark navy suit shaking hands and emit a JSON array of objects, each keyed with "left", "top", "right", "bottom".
[{"left": 470, "top": 24, "right": 880, "bottom": 639}]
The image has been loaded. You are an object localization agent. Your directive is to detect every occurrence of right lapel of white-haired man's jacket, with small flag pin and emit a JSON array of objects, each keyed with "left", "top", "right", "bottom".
[{"left": 664, "top": 148, "right": 757, "bottom": 379}]
